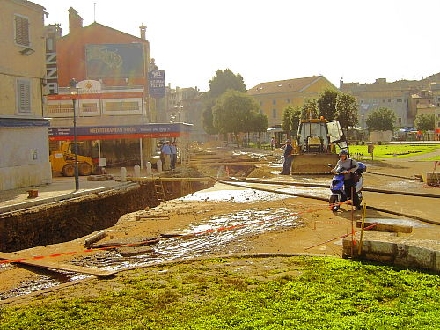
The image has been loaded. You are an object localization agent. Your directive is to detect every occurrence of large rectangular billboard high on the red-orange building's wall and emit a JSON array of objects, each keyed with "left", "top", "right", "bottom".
[{"left": 85, "top": 43, "right": 144, "bottom": 80}]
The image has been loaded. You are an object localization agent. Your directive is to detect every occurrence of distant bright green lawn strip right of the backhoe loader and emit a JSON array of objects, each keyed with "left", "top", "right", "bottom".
[{"left": 349, "top": 144, "right": 440, "bottom": 160}]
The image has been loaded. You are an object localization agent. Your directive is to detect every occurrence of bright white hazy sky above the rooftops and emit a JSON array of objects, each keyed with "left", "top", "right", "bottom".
[{"left": 37, "top": 0, "right": 440, "bottom": 91}]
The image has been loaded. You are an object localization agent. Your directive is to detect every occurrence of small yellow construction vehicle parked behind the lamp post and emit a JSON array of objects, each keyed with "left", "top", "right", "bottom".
[{"left": 49, "top": 142, "right": 93, "bottom": 176}]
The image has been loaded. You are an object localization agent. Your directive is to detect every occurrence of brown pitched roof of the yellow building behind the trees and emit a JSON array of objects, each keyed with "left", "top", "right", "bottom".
[{"left": 247, "top": 76, "right": 326, "bottom": 95}]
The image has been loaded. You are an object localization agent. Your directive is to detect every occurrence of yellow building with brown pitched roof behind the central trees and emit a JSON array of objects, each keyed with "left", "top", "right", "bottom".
[{"left": 247, "top": 76, "right": 336, "bottom": 127}]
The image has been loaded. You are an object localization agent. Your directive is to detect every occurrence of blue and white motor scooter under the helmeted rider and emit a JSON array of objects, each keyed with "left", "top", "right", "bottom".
[{"left": 329, "top": 162, "right": 367, "bottom": 211}]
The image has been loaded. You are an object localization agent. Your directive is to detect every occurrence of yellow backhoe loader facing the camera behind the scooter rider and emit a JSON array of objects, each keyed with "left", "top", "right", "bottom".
[{"left": 291, "top": 117, "right": 348, "bottom": 174}]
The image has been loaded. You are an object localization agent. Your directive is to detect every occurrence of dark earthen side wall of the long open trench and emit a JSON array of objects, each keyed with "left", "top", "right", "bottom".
[{"left": 0, "top": 184, "right": 158, "bottom": 252}]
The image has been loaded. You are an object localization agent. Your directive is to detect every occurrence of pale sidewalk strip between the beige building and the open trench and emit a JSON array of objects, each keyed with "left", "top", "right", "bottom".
[{"left": 0, "top": 170, "right": 135, "bottom": 214}]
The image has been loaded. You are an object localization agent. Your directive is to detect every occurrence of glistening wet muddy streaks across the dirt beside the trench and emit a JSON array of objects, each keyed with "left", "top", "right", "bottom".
[{"left": 0, "top": 188, "right": 302, "bottom": 300}]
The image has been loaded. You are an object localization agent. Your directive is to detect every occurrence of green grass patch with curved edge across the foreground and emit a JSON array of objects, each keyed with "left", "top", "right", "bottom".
[{"left": 0, "top": 257, "right": 440, "bottom": 330}]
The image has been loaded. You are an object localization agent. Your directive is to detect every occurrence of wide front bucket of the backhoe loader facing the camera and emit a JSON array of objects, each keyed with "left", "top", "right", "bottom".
[{"left": 291, "top": 153, "right": 339, "bottom": 175}]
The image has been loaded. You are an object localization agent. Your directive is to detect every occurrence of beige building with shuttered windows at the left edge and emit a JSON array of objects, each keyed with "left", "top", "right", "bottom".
[{"left": 0, "top": 0, "right": 52, "bottom": 190}]
